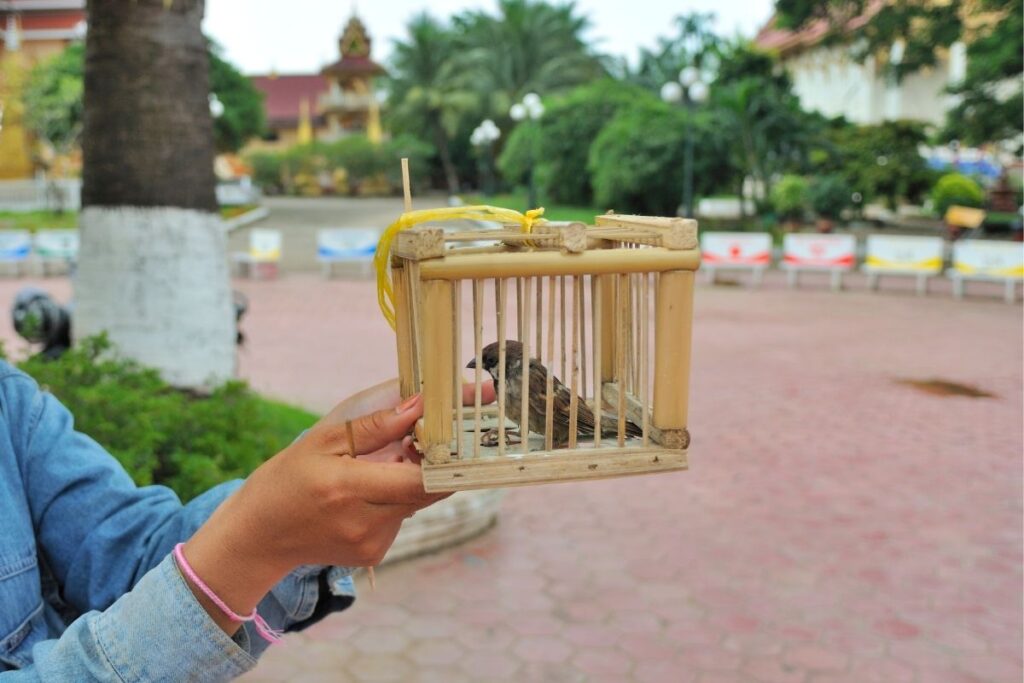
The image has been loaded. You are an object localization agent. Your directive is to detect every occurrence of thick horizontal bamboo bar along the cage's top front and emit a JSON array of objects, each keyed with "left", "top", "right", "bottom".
[{"left": 420, "top": 247, "right": 700, "bottom": 280}]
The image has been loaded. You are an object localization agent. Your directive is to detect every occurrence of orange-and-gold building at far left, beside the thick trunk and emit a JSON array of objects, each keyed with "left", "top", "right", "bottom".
[{"left": 0, "top": 0, "right": 85, "bottom": 179}]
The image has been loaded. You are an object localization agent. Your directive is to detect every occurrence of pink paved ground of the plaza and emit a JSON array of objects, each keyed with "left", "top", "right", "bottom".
[{"left": 0, "top": 275, "right": 1022, "bottom": 683}]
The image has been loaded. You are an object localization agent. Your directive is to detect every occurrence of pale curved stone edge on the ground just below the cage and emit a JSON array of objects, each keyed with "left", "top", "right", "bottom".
[{"left": 381, "top": 488, "right": 505, "bottom": 564}]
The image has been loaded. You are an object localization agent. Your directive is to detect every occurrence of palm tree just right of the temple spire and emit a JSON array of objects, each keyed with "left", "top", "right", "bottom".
[{"left": 388, "top": 12, "right": 475, "bottom": 194}]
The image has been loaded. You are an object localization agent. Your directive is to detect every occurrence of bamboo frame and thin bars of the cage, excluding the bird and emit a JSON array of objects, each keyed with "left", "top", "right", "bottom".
[{"left": 390, "top": 171, "right": 700, "bottom": 492}]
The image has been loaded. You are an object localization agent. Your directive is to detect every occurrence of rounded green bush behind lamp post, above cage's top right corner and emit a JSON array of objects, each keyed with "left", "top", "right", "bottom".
[{"left": 588, "top": 100, "right": 730, "bottom": 215}]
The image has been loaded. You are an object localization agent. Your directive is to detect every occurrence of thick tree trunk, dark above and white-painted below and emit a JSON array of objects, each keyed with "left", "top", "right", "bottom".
[{"left": 74, "top": 0, "right": 236, "bottom": 387}]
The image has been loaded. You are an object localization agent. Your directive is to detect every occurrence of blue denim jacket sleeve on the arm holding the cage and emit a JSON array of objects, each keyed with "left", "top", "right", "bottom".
[{"left": 0, "top": 374, "right": 354, "bottom": 683}]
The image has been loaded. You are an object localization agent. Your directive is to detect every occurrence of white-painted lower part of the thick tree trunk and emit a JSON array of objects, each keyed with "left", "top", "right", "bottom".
[{"left": 72, "top": 207, "right": 237, "bottom": 388}]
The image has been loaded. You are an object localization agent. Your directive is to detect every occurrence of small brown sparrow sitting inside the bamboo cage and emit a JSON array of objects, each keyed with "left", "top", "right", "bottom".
[{"left": 466, "top": 340, "right": 643, "bottom": 445}]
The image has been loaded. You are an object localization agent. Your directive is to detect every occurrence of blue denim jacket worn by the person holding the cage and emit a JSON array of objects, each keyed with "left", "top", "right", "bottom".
[{"left": 0, "top": 361, "right": 354, "bottom": 683}]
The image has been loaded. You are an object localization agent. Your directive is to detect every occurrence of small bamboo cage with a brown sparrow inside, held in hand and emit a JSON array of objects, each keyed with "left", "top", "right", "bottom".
[{"left": 383, "top": 200, "right": 700, "bottom": 492}]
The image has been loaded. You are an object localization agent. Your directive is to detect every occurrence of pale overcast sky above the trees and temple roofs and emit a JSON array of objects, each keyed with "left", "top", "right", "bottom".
[{"left": 204, "top": 0, "right": 772, "bottom": 74}]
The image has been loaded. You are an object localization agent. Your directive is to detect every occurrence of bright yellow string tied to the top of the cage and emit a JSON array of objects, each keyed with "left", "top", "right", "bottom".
[{"left": 374, "top": 205, "right": 544, "bottom": 330}]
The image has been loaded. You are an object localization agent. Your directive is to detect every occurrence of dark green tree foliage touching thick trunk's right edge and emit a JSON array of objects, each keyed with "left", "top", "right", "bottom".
[{"left": 210, "top": 41, "right": 266, "bottom": 152}]
